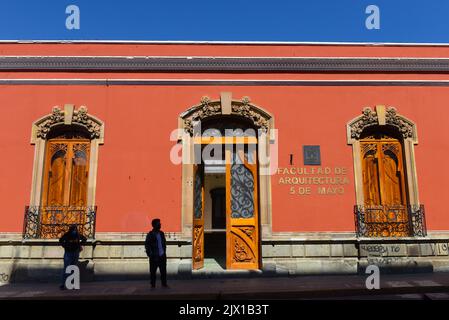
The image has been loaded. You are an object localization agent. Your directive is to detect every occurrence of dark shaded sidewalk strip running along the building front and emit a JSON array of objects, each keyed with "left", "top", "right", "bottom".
[{"left": 0, "top": 273, "right": 449, "bottom": 300}]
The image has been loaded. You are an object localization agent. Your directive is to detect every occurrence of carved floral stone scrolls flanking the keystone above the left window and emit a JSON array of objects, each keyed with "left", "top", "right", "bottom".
[{"left": 36, "top": 107, "right": 101, "bottom": 139}]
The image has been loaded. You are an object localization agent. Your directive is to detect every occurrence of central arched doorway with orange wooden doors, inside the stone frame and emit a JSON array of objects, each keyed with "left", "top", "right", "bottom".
[{"left": 192, "top": 112, "right": 260, "bottom": 270}]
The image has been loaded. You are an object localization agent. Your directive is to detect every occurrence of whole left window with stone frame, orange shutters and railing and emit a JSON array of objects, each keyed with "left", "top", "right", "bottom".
[{"left": 24, "top": 105, "right": 104, "bottom": 238}]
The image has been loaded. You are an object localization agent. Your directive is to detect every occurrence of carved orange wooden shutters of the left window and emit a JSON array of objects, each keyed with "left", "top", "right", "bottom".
[{"left": 41, "top": 139, "right": 90, "bottom": 238}]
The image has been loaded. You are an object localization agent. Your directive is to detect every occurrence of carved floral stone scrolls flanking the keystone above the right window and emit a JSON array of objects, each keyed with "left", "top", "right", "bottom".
[{"left": 350, "top": 107, "right": 414, "bottom": 139}]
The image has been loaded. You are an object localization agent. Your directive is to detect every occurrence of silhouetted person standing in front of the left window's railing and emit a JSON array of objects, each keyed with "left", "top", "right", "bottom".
[{"left": 59, "top": 224, "right": 87, "bottom": 289}]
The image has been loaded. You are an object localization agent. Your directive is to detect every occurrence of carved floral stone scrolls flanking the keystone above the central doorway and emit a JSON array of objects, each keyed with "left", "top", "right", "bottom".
[{"left": 181, "top": 96, "right": 269, "bottom": 135}]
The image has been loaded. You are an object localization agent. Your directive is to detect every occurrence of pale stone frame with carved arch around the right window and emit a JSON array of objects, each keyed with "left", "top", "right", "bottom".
[{"left": 346, "top": 105, "right": 420, "bottom": 206}]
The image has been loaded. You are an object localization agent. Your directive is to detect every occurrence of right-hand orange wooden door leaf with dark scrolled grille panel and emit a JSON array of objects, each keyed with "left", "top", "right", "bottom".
[{"left": 226, "top": 145, "right": 259, "bottom": 269}]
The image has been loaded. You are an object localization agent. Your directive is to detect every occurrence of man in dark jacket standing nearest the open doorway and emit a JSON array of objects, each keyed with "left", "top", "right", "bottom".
[{"left": 145, "top": 219, "right": 168, "bottom": 288}]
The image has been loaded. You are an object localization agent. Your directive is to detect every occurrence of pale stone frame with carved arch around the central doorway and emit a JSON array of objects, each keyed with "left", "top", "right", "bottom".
[{"left": 177, "top": 92, "right": 275, "bottom": 239}]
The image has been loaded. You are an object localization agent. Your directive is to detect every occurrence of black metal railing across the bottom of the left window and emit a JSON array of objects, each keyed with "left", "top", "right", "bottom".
[{"left": 23, "top": 206, "right": 97, "bottom": 239}]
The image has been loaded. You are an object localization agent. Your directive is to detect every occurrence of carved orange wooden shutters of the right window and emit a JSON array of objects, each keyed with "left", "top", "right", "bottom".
[{"left": 361, "top": 137, "right": 410, "bottom": 237}]
